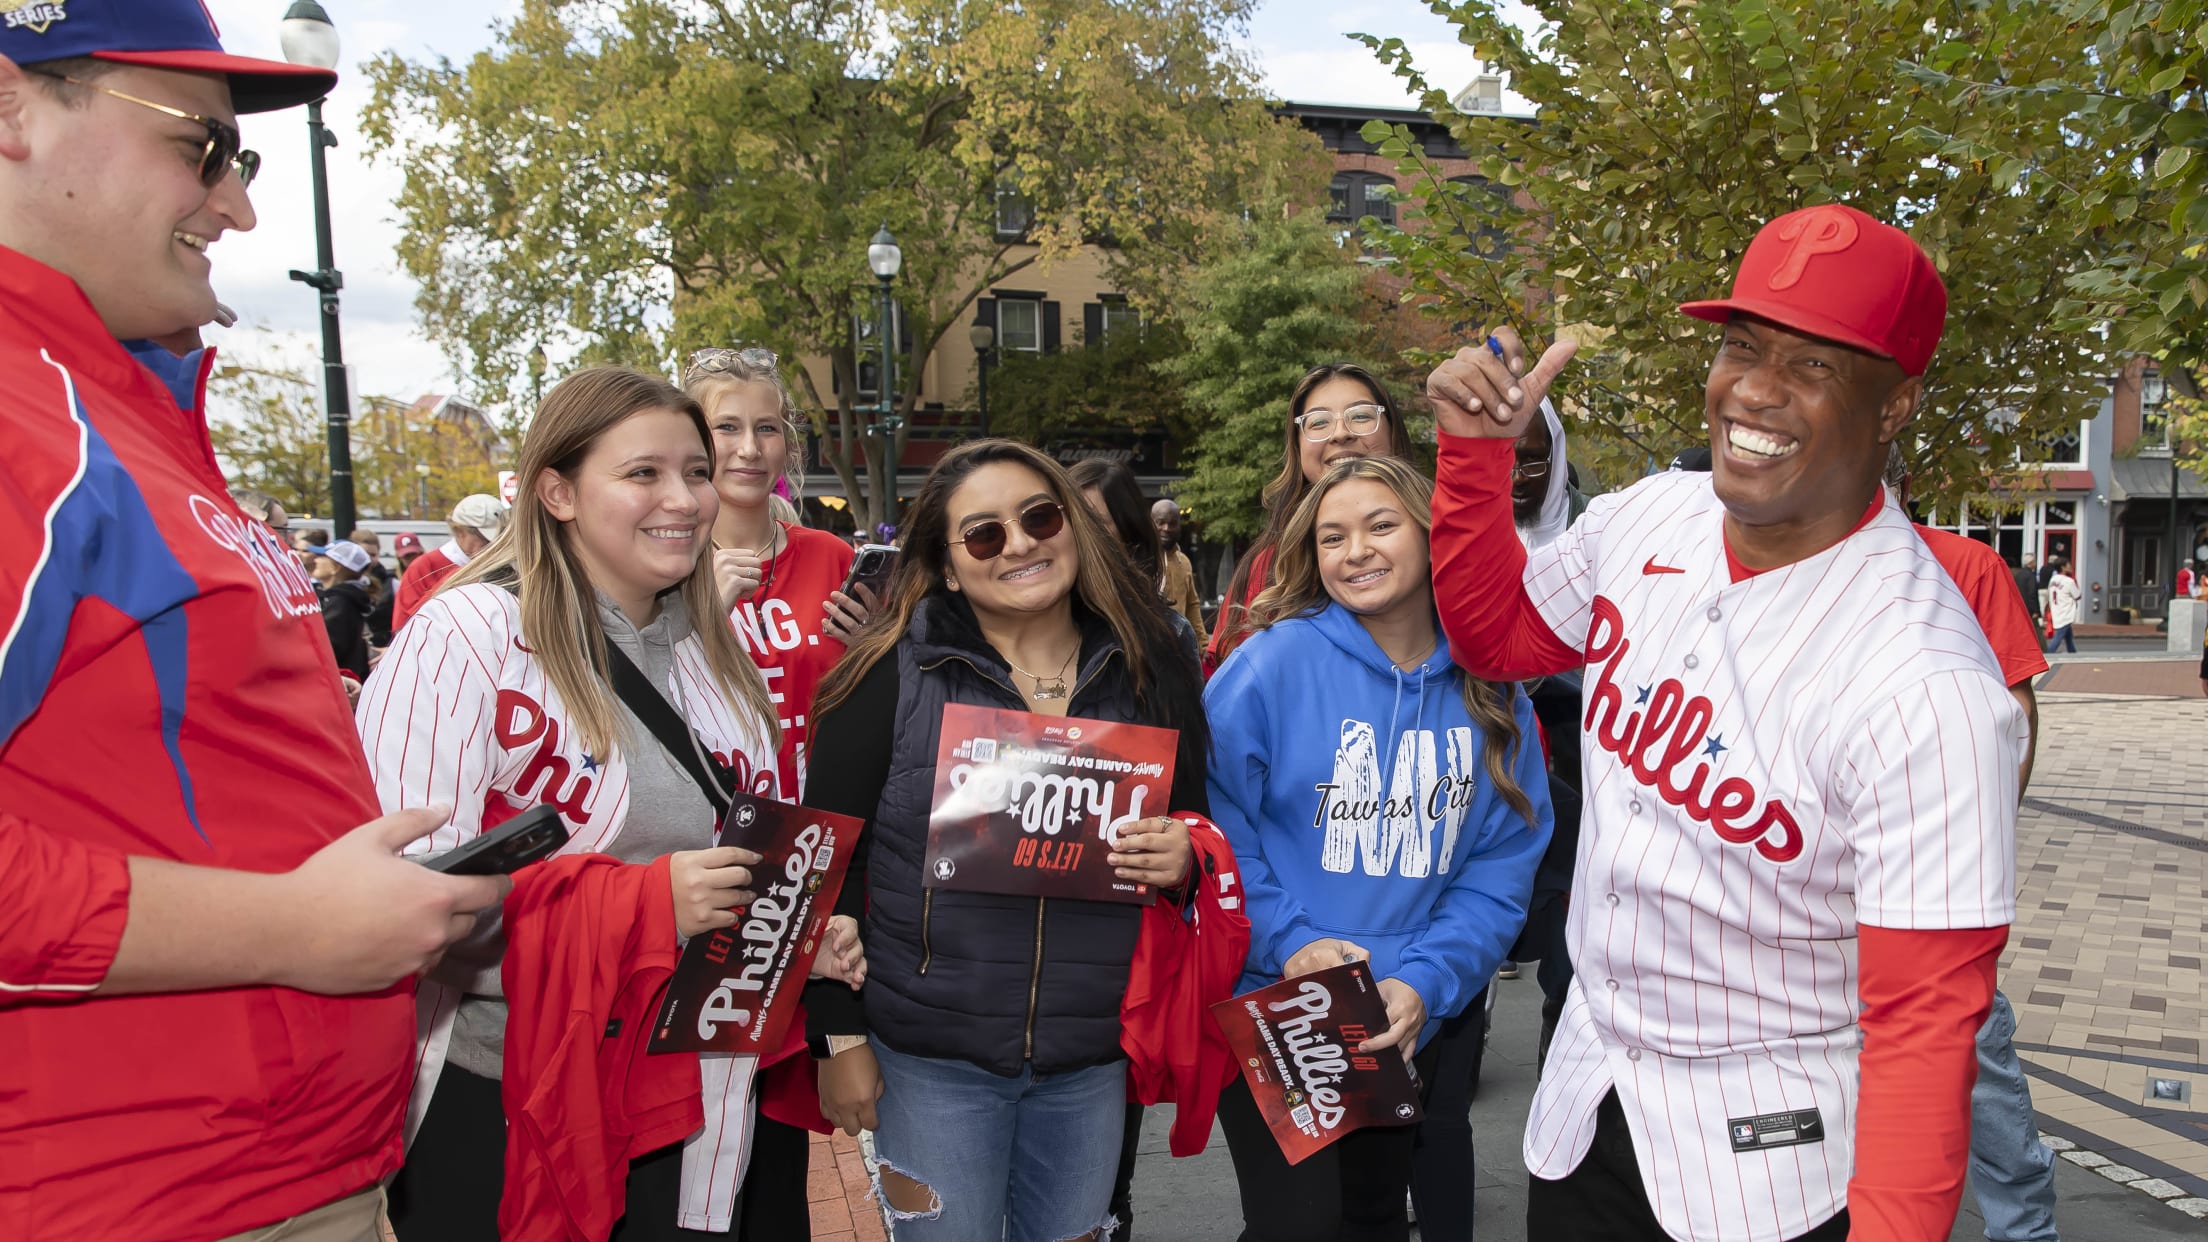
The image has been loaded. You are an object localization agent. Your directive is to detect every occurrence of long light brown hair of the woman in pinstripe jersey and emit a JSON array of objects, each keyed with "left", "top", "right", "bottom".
[{"left": 444, "top": 367, "right": 779, "bottom": 756}]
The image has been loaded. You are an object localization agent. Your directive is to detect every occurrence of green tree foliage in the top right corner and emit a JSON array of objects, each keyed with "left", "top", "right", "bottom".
[{"left": 1906, "top": 0, "right": 2208, "bottom": 396}]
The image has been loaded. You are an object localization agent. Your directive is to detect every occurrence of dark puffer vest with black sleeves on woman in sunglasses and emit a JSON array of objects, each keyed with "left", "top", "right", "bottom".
[{"left": 806, "top": 597, "right": 1208, "bottom": 1076}]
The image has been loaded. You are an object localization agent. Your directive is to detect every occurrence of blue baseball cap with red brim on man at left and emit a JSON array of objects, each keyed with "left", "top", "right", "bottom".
[{"left": 0, "top": 0, "right": 338, "bottom": 113}]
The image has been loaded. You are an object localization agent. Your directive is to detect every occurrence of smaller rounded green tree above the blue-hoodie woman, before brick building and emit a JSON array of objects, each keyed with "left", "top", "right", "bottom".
[{"left": 1159, "top": 210, "right": 1371, "bottom": 539}]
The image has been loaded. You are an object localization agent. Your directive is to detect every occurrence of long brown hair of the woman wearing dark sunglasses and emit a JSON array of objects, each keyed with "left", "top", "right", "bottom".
[{"left": 813, "top": 440, "right": 1210, "bottom": 754}]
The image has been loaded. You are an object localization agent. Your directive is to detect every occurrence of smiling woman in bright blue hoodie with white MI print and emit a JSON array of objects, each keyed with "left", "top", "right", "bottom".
[{"left": 1203, "top": 457, "right": 1550, "bottom": 1242}]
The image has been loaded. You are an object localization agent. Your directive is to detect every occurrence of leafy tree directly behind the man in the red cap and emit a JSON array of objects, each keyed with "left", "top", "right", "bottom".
[{"left": 1360, "top": 0, "right": 2100, "bottom": 499}]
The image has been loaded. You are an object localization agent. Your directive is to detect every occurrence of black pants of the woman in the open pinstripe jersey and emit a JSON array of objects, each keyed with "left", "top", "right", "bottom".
[{"left": 391, "top": 1065, "right": 813, "bottom": 1242}]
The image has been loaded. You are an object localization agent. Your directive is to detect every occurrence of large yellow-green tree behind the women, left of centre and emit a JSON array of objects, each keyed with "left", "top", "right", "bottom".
[{"left": 367, "top": 0, "right": 1323, "bottom": 524}]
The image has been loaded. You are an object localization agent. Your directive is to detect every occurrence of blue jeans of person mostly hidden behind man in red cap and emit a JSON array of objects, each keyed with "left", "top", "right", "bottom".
[{"left": 1970, "top": 990, "right": 2060, "bottom": 1242}]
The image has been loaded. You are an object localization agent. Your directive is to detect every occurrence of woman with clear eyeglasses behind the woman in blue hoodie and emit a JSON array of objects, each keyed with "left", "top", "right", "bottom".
[{"left": 1203, "top": 362, "right": 1411, "bottom": 674}]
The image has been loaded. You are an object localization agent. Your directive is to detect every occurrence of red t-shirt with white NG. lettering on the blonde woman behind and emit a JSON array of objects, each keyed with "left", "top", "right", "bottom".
[{"left": 729, "top": 524, "right": 857, "bottom": 798}]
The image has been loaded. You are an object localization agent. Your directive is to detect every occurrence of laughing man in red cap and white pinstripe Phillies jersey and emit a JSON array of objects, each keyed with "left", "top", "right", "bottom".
[{"left": 1426, "top": 206, "right": 2027, "bottom": 1242}]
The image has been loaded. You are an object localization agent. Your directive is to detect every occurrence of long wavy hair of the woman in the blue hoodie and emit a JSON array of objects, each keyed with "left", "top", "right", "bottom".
[{"left": 1250, "top": 457, "right": 1532, "bottom": 822}]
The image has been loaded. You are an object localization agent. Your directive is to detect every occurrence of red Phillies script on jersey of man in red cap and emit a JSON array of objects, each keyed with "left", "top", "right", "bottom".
[{"left": 1585, "top": 594, "right": 1802, "bottom": 862}]
